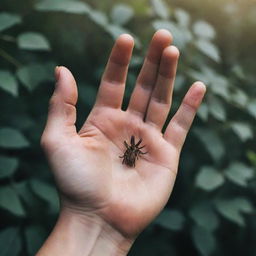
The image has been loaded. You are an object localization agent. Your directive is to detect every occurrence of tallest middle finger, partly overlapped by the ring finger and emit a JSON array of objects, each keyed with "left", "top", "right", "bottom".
[{"left": 128, "top": 29, "right": 172, "bottom": 118}]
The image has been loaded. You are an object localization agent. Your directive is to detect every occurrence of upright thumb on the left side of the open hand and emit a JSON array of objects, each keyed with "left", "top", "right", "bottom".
[{"left": 43, "top": 67, "right": 78, "bottom": 133}]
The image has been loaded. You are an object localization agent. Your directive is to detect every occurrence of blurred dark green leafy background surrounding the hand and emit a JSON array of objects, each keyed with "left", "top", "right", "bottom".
[{"left": 0, "top": 0, "right": 256, "bottom": 256}]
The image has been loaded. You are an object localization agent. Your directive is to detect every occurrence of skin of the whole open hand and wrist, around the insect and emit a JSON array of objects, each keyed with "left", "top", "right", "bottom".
[{"left": 38, "top": 30, "right": 205, "bottom": 255}]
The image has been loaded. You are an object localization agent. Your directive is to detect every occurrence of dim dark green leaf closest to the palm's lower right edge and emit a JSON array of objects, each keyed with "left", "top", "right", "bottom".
[{"left": 155, "top": 209, "right": 185, "bottom": 231}]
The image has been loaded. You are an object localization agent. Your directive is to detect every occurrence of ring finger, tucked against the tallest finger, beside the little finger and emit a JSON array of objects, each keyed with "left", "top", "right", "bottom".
[{"left": 145, "top": 46, "right": 179, "bottom": 130}]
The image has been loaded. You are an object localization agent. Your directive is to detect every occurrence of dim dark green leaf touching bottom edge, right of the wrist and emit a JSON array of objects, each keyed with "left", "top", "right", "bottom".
[{"left": 192, "top": 226, "right": 216, "bottom": 256}]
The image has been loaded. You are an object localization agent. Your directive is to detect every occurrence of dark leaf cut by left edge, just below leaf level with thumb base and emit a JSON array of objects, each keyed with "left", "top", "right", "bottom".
[{"left": 0, "top": 156, "right": 19, "bottom": 179}]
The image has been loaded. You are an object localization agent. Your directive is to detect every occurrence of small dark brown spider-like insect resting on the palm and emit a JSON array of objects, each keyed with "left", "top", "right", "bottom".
[{"left": 119, "top": 135, "right": 147, "bottom": 167}]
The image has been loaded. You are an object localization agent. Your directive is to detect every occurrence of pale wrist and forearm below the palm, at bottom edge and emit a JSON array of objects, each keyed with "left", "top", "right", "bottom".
[{"left": 37, "top": 210, "right": 133, "bottom": 256}]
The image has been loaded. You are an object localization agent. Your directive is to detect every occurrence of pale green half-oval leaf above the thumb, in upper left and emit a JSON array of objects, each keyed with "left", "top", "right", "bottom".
[{"left": 18, "top": 32, "right": 51, "bottom": 51}]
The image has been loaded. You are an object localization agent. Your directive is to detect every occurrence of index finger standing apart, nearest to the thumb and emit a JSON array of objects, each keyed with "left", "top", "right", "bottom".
[{"left": 96, "top": 34, "right": 134, "bottom": 108}]
